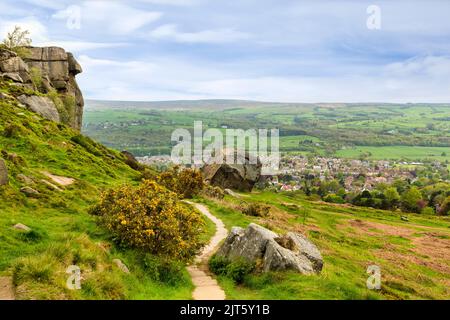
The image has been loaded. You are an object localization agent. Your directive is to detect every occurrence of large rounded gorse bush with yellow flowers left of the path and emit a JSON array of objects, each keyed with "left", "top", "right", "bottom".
[{"left": 90, "top": 180, "right": 204, "bottom": 261}]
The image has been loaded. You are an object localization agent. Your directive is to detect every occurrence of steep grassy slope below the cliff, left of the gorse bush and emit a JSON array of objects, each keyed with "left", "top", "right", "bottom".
[{"left": 0, "top": 82, "right": 193, "bottom": 299}]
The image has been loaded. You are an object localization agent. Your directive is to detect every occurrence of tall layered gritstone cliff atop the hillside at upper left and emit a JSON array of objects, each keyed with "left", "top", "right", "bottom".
[{"left": 0, "top": 47, "right": 84, "bottom": 130}]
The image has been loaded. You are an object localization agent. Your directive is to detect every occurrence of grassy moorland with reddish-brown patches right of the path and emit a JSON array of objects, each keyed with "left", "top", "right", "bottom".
[{"left": 197, "top": 192, "right": 450, "bottom": 299}]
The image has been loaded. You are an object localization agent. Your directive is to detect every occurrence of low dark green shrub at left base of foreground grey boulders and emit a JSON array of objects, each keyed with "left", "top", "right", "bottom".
[{"left": 209, "top": 255, "right": 255, "bottom": 283}]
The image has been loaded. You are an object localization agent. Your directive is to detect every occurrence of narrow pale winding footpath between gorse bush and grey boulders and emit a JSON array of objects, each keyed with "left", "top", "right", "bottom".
[{"left": 186, "top": 201, "right": 228, "bottom": 300}]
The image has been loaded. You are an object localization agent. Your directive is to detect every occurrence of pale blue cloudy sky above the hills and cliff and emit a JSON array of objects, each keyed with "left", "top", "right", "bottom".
[{"left": 0, "top": 0, "right": 450, "bottom": 103}]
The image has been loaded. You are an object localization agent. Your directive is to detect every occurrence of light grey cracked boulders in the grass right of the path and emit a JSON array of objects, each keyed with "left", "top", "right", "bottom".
[{"left": 217, "top": 223, "right": 323, "bottom": 274}]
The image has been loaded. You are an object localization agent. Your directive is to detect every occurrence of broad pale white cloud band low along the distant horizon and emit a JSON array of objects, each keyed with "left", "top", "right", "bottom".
[{"left": 80, "top": 56, "right": 450, "bottom": 102}]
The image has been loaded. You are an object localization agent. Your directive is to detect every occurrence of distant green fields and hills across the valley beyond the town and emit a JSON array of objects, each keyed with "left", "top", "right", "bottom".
[{"left": 83, "top": 100, "right": 450, "bottom": 161}]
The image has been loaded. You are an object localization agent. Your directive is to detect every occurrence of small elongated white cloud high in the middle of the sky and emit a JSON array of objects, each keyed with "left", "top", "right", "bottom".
[{"left": 150, "top": 24, "right": 250, "bottom": 44}]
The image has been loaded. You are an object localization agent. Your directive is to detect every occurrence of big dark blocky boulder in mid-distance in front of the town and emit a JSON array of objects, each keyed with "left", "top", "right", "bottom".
[{"left": 201, "top": 151, "right": 261, "bottom": 192}]
